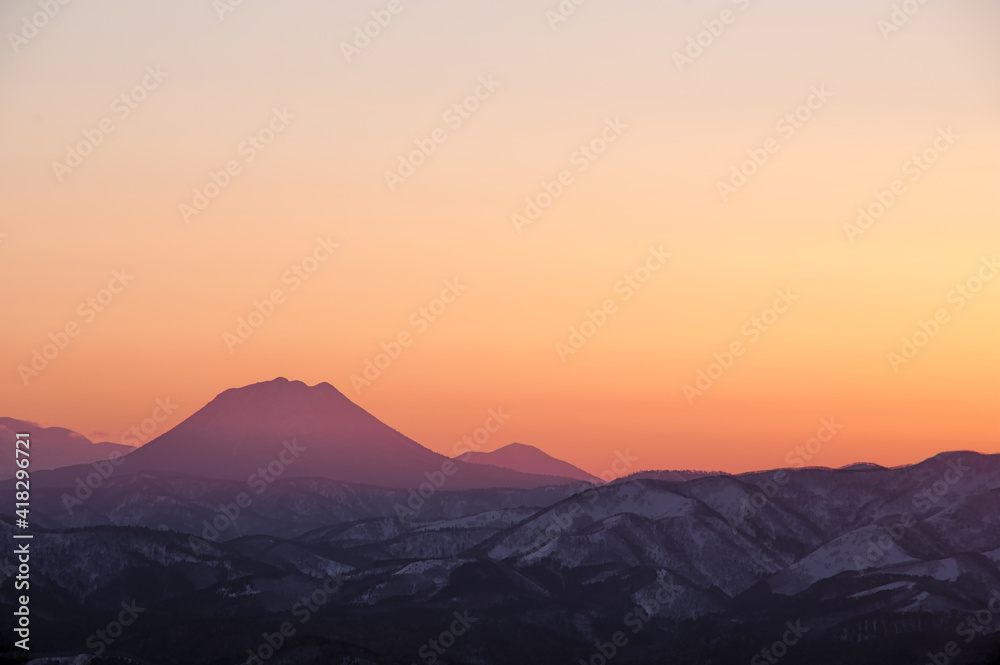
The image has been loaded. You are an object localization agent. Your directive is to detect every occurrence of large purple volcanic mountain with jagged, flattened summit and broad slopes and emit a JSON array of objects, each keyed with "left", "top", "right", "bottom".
[{"left": 107, "top": 378, "right": 574, "bottom": 490}]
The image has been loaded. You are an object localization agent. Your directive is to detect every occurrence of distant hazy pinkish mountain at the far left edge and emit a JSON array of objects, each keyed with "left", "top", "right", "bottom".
[{"left": 0, "top": 418, "right": 135, "bottom": 480}]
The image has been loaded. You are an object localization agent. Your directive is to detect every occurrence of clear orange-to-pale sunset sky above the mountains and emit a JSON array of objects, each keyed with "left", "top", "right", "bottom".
[{"left": 0, "top": 0, "right": 1000, "bottom": 474}]
